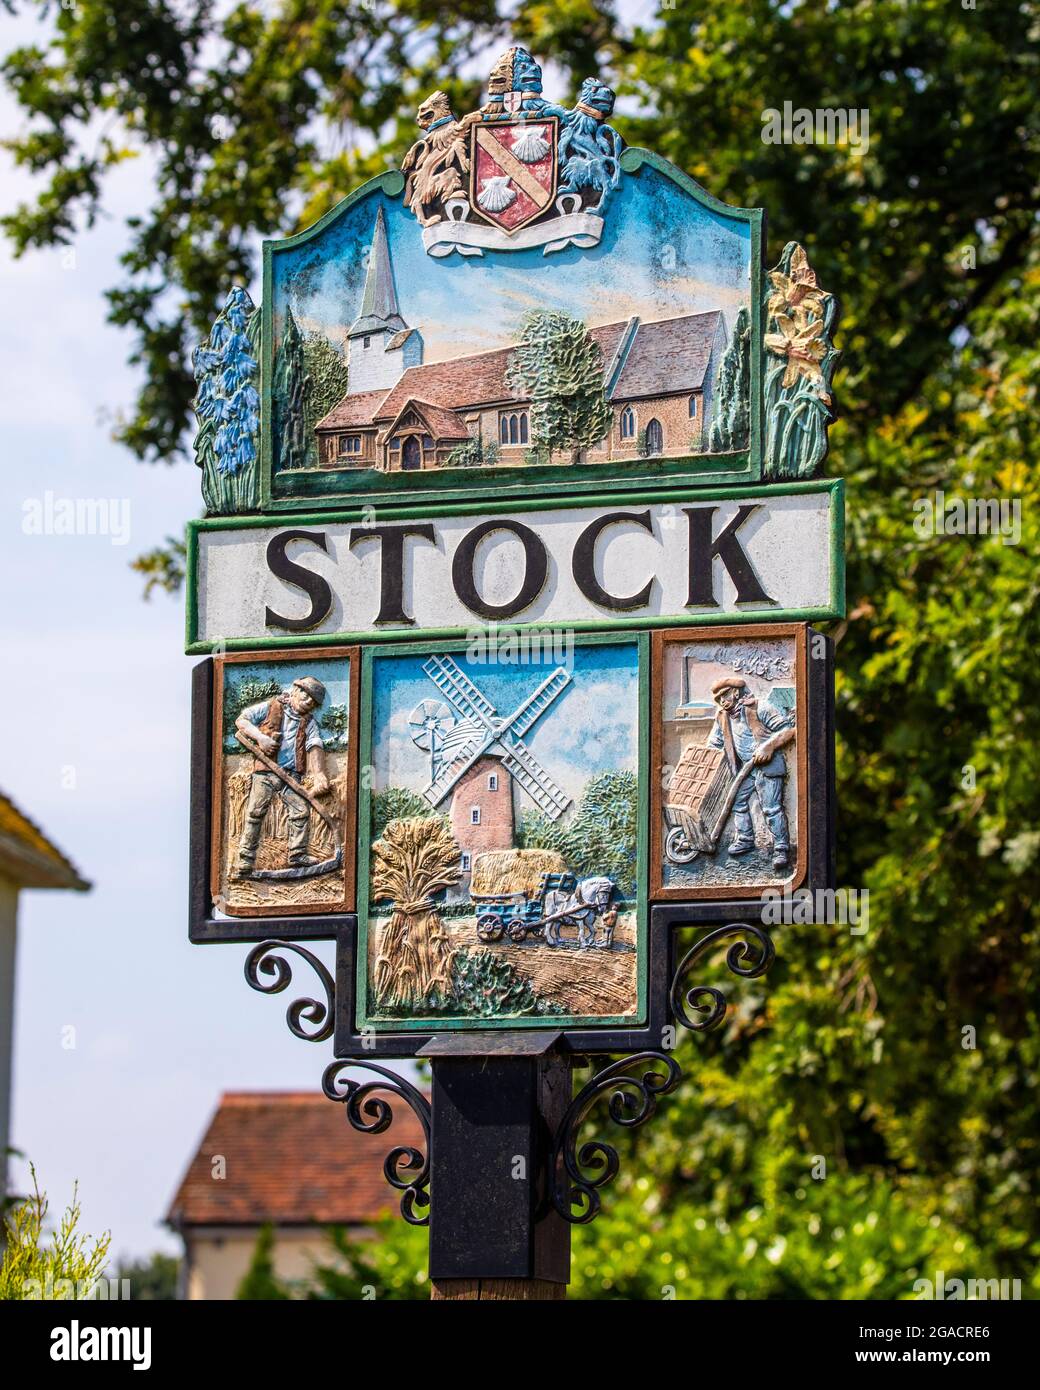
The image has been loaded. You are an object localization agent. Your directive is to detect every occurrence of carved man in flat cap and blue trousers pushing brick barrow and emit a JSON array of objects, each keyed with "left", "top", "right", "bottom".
[{"left": 708, "top": 676, "right": 794, "bottom": 873}]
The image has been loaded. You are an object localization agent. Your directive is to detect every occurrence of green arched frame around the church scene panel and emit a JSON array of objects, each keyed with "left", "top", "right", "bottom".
[{"left": 260, "top": 147, "right": 766, "bottom": 513}]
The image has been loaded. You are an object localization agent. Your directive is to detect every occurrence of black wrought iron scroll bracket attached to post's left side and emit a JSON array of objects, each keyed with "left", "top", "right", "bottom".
[{"left": 321, "top": 1058, "right": 431, "bottom": 1226}]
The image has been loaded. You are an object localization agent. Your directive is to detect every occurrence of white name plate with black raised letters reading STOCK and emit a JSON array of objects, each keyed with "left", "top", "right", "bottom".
[{"left": 188, "top": 481, "right": 844, "bottom": 652}]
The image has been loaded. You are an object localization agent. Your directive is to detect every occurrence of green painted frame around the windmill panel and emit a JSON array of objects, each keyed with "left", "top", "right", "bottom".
[{"left": 353, "top": 632, "right": 651, "bottom": 1033}]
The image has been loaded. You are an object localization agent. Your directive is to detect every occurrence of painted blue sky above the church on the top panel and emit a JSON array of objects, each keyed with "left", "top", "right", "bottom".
[{"left": 273, "top": 165, "right": 751, "bottom": 363}]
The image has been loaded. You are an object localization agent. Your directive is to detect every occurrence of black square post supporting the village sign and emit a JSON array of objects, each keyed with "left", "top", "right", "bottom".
[{"left": 423, "top": 1033, "right": 571, "bottom": 1300}]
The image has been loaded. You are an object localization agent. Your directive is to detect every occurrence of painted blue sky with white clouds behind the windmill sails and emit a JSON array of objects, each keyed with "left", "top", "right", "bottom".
[{"left": 373, "top": 642, "right": 640, "bottom": 812}]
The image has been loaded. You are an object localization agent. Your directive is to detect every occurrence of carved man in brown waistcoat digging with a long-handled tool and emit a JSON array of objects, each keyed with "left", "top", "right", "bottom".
[{"left": 234, "top": 676, "right": 328, "bottom": 878}]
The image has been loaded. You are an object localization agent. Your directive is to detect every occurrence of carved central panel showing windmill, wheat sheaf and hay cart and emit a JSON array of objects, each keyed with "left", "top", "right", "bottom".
[{"left": 357, "top": 637, "right": 647, "bottom": 1031}]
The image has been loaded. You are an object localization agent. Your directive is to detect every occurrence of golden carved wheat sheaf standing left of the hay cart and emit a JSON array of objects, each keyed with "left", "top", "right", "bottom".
[{"left": 371, "top": 817, "right": 462, "bottom": 1012}]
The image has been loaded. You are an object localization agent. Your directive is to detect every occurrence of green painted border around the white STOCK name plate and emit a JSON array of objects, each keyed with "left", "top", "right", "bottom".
[{"left": 185, "top": 478, "right": 845, "bottom": 656}]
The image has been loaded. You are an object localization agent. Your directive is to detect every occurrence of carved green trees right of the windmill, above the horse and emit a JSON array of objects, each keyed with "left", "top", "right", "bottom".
[{"left": 517, "top": 771, "right": 640, "bottom": 898}]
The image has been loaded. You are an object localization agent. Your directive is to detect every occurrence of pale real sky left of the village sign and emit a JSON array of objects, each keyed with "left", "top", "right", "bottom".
[{"left": 0, "top": 17, "right": 340, "bottom": 1273}]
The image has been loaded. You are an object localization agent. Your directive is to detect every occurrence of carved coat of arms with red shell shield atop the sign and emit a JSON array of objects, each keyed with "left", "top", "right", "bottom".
[{"left": 402, "top": 47, "right": 621, "bottom": 256}]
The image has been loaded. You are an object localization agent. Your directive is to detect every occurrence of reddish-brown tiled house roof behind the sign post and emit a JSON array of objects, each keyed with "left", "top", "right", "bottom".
[{"left": 165, "top": 1091, "right": 424, "bottom": 1229}]
